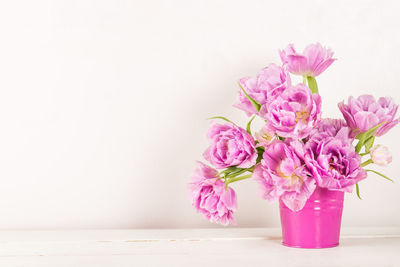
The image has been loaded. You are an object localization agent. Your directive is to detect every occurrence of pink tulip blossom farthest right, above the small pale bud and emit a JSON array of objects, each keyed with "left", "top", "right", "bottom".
[{"left": 338, "top": 95, "right": 400, "bottom": 136}]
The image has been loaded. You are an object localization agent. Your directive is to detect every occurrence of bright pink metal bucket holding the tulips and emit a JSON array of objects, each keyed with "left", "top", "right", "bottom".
[{"left": 279, "top": 187, "right": 344, "bottom": 248}]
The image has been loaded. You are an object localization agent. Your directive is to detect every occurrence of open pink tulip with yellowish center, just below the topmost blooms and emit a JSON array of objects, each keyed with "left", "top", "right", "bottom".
[{"left": 260, "top": 84, "right": 321, "bottom": 139}]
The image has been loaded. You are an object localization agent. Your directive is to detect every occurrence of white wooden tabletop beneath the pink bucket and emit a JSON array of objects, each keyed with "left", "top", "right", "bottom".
[{"left": 0, "top": 228, "right": 400, "bottom": 267}]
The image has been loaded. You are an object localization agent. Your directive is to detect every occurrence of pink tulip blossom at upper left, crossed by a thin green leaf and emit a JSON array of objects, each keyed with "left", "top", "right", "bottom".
[{"left": 233, "top": 64, "right": 290, "bottom": 116}]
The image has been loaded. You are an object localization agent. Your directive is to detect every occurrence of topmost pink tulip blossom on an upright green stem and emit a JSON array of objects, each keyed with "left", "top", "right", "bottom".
[{"left": 279, "top": 43, "right": 336, "bottom": 77}]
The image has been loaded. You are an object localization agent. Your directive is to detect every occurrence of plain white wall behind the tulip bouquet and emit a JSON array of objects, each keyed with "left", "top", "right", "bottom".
[{"left": 0, "top": 0, "right": 400, "bottom": 229}]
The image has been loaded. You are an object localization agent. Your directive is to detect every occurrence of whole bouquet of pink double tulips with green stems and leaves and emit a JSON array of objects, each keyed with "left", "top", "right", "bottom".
[{"left": 189, "top": 44, "right": 399, "bottom": 225}]
